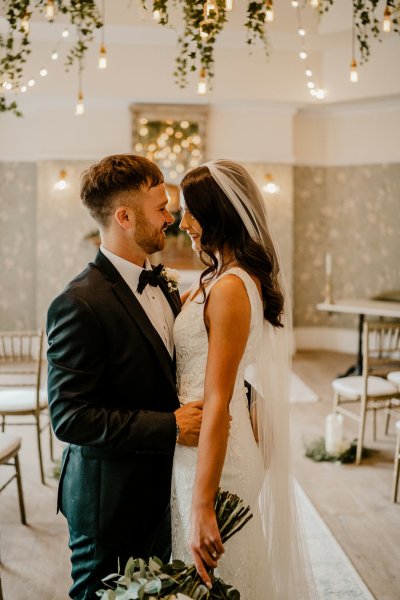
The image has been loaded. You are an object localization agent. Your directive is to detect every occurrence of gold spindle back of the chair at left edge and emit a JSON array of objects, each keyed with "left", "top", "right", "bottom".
[{"left": 0, "top": 330, "right": 44, "bottom": 405}]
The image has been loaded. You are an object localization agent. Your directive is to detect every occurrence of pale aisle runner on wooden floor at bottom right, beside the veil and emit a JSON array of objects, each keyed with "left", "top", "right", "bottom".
[{"left": 296, "top": 485, "right": 374, "bottom": 600}]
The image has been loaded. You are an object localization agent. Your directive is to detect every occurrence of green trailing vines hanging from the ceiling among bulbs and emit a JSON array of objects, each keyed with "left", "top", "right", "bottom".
[{"left": 0, "top": 0, "right": 400, "bottom": 116}]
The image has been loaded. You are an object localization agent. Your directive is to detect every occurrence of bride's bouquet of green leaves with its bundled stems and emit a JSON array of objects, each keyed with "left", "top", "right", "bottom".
[{"left": 97, "top": 490, "right": 253, "bottom": 600}]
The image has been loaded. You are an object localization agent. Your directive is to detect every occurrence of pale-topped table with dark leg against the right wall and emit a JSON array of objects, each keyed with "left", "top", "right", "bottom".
[{"left": 317, "top": 298, "right": 400, "bottom": 375}]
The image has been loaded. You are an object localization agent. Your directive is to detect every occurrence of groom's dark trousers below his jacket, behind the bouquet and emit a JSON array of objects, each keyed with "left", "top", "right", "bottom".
[{"left": 69, "top": 510, "right": 171, "bottom": 600}]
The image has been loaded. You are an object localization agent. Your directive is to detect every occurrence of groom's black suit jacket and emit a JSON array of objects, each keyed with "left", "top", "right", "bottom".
[{"left": 47, "top": 251, "right": 180, "bottom": 556}]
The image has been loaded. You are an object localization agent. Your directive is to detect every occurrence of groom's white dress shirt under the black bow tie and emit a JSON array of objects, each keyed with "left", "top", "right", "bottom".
[{"left": 100, "top": 246, "right": 174, "bottom": 356}]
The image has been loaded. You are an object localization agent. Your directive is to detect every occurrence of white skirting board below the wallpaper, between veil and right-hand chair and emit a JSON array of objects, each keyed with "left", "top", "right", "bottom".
[{"left": 294, "top": 327, "right": 358, "bottom": 354}]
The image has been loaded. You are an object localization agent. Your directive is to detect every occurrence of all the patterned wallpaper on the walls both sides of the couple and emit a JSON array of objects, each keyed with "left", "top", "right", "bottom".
[{"left": 0, "top": 161, "right": 400, "bottom": 329}]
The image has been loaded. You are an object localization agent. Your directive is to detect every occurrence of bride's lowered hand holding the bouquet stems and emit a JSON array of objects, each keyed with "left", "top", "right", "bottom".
[{"left": 189, "top": 505, "right": 224, "bottom": 589}]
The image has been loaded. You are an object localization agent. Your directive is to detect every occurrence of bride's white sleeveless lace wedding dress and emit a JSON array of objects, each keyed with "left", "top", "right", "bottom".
[{"left": 171, "top": 267, "right": 271, "bottom": 600}]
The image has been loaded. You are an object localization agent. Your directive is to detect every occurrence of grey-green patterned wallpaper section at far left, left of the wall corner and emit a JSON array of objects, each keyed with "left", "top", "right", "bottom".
[{"left": 0, "top": 162, "right": 36, "bottom": 330}]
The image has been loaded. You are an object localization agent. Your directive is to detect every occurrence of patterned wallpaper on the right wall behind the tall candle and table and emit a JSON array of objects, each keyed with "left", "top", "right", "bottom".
[{"left": 293, "top": 164, "right": 400, "bottom": 327}]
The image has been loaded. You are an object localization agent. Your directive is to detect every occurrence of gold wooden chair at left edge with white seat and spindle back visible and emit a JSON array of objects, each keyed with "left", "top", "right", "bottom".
[{"left": 0, "top": 331, "right": 53, "bottom": 483}]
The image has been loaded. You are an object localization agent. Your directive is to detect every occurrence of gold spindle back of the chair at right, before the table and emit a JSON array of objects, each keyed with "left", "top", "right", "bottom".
[{"left": 363, "top": 321, "right": 400, "bottom": 377}]
